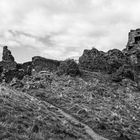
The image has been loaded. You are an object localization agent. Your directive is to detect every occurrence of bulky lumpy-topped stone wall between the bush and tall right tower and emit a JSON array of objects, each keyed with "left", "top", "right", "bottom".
[{"left": 79, "top": 48, "right": 125, "bottom": 73}]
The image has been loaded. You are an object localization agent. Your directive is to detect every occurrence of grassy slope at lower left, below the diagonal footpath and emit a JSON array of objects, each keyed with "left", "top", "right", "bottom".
[{"left": 0, "top": 86, "right": 96, "bottom": 140}]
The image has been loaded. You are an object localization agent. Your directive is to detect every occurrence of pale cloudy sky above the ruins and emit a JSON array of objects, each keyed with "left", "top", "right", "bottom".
[{"left": 0, "top": 0, "right": 140, "bottom": 62}]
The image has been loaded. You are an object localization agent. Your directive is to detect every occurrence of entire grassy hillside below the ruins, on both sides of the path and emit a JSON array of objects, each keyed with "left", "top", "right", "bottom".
[{"left": 0, "top": 71, "right": 140, "bottom": 140}]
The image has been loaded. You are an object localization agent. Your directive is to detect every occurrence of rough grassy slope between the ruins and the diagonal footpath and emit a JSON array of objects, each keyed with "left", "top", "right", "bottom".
[{"left": 20, "top": 71, "right": 140, "bottom": 140}]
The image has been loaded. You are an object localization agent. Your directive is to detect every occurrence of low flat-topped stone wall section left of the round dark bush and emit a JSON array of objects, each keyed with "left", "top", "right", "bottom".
[{"left": 32, "top": 56, "right": 60, "bottom": 72}]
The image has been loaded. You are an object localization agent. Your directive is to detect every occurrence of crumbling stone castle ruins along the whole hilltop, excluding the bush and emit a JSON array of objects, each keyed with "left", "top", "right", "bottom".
[{"left": 0, "top": 29, "right": 140, "bottom": 81}]
